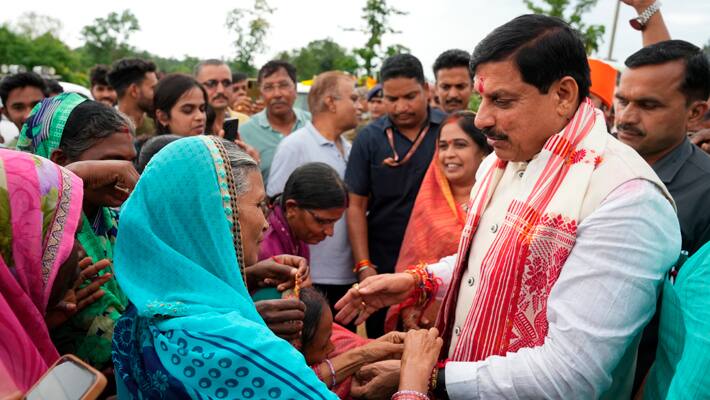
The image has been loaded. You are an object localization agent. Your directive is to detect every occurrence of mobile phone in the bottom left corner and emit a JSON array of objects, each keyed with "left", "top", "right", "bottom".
[{"left": 25, "top": 354, "right": 106, "bottom": 400}]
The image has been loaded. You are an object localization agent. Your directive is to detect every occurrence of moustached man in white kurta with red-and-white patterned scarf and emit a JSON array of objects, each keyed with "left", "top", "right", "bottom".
[{"left": 336, "top": 15, "right": 680, "bottom": 399}]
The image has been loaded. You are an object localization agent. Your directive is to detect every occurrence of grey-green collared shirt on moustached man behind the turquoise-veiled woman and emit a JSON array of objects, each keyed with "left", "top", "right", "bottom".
[{"left": 239, "top": 108, "right": 311, "bottom": 182}]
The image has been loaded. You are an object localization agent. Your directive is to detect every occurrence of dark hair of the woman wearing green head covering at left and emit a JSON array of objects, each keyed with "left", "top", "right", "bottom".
[{"left": 59, "top": 100, "right": 135, "bottom": 159}]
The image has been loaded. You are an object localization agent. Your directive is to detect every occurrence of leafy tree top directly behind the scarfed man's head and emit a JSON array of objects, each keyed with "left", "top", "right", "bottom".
[{"left": 523, "top": 0, "right": 605, "bottom": 54}]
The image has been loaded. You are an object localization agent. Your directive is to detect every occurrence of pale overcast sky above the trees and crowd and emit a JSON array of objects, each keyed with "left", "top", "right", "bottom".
[{"left": 0, "top": 0, "right": 710, "bottom": 77}]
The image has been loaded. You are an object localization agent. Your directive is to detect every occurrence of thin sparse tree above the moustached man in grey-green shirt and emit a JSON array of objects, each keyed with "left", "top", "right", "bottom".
[{"left": 226, "top": 0, "right": 276, "bottom": 74}]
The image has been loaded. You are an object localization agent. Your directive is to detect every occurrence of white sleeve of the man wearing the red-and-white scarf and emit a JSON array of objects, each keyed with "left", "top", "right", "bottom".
[{"left": 446, "top": 180, "right": 681, "bottom": 399}]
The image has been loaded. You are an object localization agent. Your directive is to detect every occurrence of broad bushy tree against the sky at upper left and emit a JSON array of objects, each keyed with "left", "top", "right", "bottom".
[{"left": 81, "top": 10, "right": 140, "bottom": 65}]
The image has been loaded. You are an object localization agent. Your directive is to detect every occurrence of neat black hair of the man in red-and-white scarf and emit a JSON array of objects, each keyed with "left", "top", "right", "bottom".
[{"left": 470, "top": 14, "right": 591, "bottom": 103}]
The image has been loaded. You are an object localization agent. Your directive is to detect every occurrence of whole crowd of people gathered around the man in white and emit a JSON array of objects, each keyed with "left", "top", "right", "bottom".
[{"left": 0, "top": 0, "right": 710, "bottom": 400}]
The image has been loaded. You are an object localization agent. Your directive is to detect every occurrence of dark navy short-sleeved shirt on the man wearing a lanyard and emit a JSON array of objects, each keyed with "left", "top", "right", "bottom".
[{"left": 345, "top": 109, "right": 446, "bottom": 273}]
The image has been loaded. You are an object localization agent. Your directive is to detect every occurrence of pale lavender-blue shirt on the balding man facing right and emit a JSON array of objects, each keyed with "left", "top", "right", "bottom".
[{"left": 266, "top": 122, "right": 357, "bottom": 285}]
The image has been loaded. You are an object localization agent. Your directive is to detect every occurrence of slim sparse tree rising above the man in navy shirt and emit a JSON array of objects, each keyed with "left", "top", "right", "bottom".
[{"left": 347, "top": 0, "right": 407, "bottom": 76}]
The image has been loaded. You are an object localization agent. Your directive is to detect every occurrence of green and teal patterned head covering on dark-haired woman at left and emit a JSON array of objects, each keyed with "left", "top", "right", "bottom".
[{"left": 17, "top": 93, "right": 88, "bottom": 158}]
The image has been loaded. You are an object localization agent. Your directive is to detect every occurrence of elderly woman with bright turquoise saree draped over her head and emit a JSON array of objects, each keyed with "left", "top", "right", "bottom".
[{"left": 113, "top": 136, "right": 336, "bottom": 399}]
